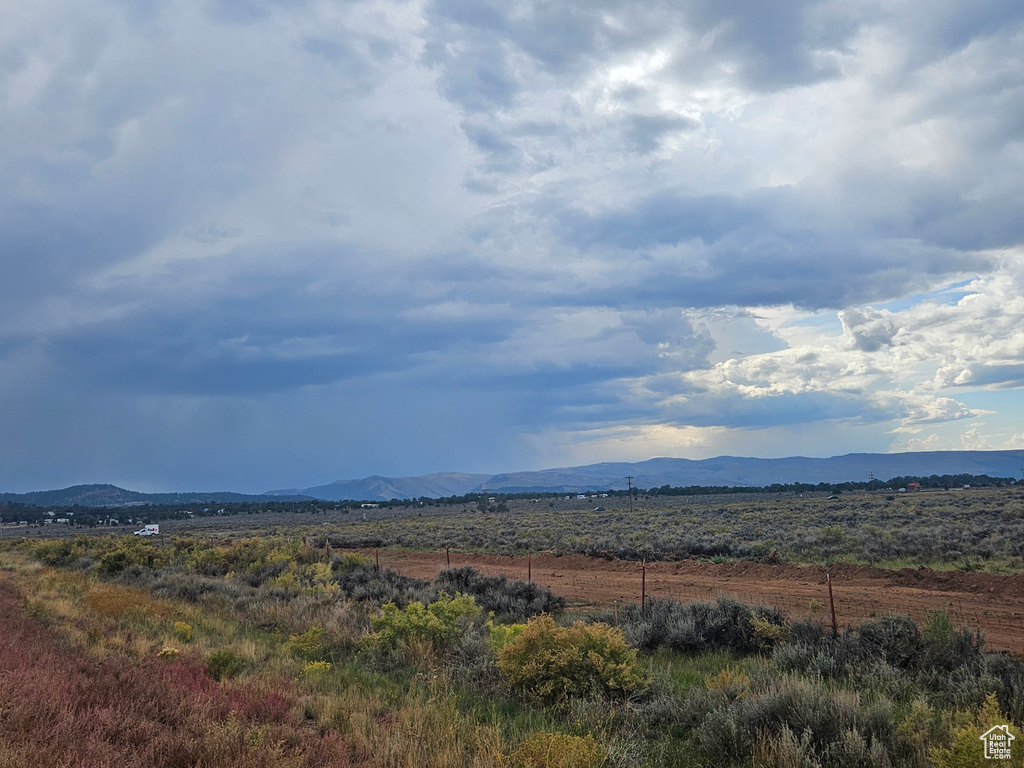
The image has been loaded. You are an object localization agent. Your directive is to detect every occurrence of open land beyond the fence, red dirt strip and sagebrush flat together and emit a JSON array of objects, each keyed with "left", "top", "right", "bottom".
[{"left": 14, "top": 488, "right": 1024, "bottom": 654}]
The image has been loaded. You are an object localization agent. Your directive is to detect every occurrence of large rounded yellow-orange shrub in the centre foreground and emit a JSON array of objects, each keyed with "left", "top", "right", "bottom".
[{"left": 498, "top": 615, "right": 646, "bottom": 701}]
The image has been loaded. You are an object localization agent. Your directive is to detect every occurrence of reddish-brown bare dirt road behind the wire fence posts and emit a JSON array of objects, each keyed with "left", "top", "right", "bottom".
[{"left": 368, "top": 550, "right": 1024, "bottom": 655}]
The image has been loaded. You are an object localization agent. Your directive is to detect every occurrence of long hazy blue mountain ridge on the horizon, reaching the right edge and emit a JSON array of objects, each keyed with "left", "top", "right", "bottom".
[{"left": 267, "top": 451, "right": 1024, "bottom": 501}]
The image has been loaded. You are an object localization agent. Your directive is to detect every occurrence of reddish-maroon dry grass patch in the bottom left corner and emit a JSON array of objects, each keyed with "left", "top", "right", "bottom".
[{"left": 0, "top": 585, "right": 348, "bottom": 768}]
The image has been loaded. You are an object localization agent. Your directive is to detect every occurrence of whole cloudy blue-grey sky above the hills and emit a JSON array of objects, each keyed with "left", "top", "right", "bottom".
[{"left": 0, "top": 0, "right": 1024, "bottom": 493}]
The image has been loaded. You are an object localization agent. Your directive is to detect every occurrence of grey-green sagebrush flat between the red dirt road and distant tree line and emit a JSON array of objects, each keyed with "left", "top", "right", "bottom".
[{"left": 16, "top": 488, "right": 1024, "bottom": 572}]
